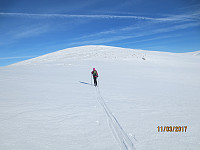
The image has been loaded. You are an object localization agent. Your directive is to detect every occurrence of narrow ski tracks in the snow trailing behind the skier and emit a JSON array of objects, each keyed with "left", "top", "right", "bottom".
[{"left": 96, "top": 87, "right": 136, "bottom": 150}]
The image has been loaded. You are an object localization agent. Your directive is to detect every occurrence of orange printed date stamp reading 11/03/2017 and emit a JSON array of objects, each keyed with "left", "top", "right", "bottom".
[{"left": 157, "top": 126, "right": 187, "bottom": 132}]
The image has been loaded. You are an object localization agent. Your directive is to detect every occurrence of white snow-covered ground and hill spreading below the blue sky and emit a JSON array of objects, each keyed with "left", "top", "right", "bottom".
[{"left": 0, "top": 46, "right": 200, "bottom": 150}]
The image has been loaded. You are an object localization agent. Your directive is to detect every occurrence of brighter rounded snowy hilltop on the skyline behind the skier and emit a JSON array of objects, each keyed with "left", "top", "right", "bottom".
[{"left": 14, "top": 45, "right": 191, "bottom": 65}]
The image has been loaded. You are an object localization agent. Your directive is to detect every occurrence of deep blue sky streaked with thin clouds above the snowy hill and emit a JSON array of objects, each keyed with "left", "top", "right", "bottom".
[{"left": 0, "top": 0, "right": 200, "bottom": 66}]
